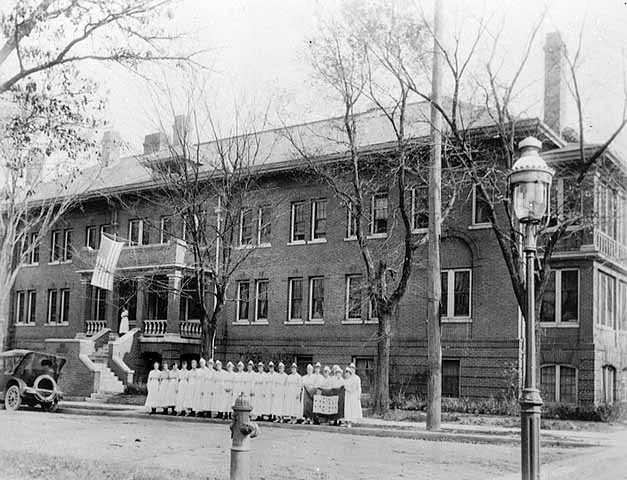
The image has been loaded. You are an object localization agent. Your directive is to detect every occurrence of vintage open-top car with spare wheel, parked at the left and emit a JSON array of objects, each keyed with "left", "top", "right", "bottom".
[{"left": 0, "top": 350, "right": 65, "bottom": 411}]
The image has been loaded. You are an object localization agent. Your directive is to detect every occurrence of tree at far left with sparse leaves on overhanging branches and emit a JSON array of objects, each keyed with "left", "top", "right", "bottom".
[{"left": 0, "top": 0, "right": 199, "bottom": 349}]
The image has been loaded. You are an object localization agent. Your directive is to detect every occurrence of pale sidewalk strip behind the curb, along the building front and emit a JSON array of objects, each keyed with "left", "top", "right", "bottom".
[{"left": 58, "top": 401, "right": 607, "bottom": 447}]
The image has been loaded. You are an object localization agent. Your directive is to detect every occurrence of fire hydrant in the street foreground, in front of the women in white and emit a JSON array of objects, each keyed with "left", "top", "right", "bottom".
[{"left": 231, "top": 393, "right": 259, "bottom": 480}]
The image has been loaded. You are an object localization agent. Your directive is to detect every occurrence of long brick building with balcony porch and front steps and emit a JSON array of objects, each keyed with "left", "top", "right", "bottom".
[{"left": 11, "top": 32, "right": 627, "bottom": 404}]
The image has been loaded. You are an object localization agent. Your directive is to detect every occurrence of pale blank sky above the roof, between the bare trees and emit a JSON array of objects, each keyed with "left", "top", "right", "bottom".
[{"left": 98, "top": 0, "right": 627, "bottom": 153}]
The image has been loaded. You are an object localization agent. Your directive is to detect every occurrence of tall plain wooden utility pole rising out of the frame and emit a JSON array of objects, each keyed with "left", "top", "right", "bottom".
[{"left": 427, "top": 0, "right": 443, "bottom": 430}]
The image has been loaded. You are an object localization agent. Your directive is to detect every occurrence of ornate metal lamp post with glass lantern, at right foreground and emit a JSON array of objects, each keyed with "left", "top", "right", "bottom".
[{"left": 509, "top": 137, "right": 554, "bottom": 480}]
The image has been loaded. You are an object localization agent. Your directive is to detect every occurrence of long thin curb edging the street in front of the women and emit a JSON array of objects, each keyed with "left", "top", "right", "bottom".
[{"left": 57, "top": 406, "right": 599, "bottom": 448}]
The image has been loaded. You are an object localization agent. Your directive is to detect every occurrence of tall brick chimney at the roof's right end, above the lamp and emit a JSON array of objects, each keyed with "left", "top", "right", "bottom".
[{"left": 544, "top": 31, "right": 567, "bottom": 135}]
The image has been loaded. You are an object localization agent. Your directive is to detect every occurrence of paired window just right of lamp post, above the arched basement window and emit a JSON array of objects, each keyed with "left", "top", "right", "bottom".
[{"left": 540, "top": 270, "right": 579, "bottom": 324}]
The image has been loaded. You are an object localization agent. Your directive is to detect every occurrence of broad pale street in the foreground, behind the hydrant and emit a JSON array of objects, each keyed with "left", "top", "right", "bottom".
[{"left": 0, "top": 411, "right": 600, "bottom": 480}]
